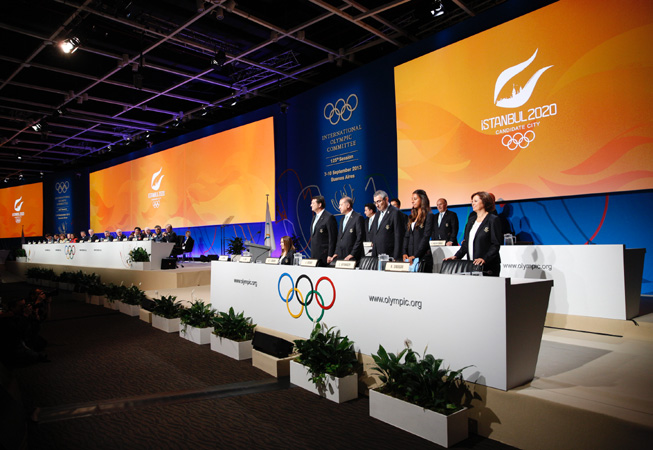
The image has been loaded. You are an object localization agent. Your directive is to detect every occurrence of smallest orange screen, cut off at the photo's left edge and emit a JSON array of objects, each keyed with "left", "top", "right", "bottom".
[{"left": 0, "top": 183, "right": 43, "bottom": 238}]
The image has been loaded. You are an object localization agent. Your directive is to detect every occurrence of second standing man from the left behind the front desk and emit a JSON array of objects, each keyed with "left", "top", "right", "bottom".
[{"left": 327, "top": 197, "right": 365, "bottom": 264}]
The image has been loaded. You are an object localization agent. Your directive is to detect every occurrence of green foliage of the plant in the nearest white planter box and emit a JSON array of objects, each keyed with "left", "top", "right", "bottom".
[{"left": 372, "top": 345, "right": 470, "bottom": 415}]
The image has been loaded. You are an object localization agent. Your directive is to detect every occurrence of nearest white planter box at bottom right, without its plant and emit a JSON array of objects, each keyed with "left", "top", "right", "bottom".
[{"left": 366, "top": 388, "right": 468, "bottom": 448}]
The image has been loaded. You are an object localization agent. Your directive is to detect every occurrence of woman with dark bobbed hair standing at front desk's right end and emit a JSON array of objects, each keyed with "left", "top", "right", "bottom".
[{"left": 446, "top": 192, "right": 503, "bottom": 277}]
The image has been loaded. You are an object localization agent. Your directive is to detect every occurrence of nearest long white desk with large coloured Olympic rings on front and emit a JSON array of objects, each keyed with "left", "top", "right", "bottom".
[{"left": 211, "top": 261, "right": 553, "bottom": 390}]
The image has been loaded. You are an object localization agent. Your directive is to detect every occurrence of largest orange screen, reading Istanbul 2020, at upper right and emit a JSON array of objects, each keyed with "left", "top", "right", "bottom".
[{"left": 395, "top": 0, "right": 653, "bottom": 204}]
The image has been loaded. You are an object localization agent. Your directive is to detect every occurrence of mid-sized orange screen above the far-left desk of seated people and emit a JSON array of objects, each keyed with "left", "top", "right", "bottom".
[{"left": 90, "top": 117, "right": 275, "bottom": 231}]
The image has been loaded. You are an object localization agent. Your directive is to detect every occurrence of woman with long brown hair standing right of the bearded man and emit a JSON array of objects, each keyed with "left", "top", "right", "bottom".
[{"left": 403, "top": 189, "right": 435, "bottom": 273}]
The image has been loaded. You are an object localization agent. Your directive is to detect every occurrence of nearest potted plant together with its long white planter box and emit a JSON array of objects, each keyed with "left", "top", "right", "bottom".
[{"left": 370, "top": 345, "right": 469, "bottom": 447}]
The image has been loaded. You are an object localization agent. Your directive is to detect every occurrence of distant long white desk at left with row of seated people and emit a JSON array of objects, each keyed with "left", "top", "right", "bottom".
[{"left": 23, "top": 241, "right": 174, "bottom": 269}]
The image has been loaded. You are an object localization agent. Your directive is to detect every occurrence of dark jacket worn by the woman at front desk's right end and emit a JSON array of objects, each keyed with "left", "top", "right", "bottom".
[{"left": 456, "top": 214, "right": 503, "bottom": 277}]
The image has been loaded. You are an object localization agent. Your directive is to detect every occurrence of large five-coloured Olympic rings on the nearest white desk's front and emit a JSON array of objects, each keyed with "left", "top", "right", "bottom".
[{"left": 277, "top": 272, "right": 336, "bottom": 323}]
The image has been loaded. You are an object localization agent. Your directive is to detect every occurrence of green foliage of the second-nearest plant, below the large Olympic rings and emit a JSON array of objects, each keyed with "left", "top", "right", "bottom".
[{"left": 295, "top": 323, "right": 359, "bottom": 387}]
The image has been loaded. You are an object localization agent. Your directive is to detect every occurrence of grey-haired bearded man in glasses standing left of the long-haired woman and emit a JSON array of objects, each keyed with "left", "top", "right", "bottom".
[{"left": 371, "top": 191, "right": 406, "bottom": 261}]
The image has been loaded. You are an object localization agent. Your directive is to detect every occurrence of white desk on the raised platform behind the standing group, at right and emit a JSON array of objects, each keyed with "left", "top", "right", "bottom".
[{"left": 433, "top": 245, "right": 646, "bottom": 320}]
